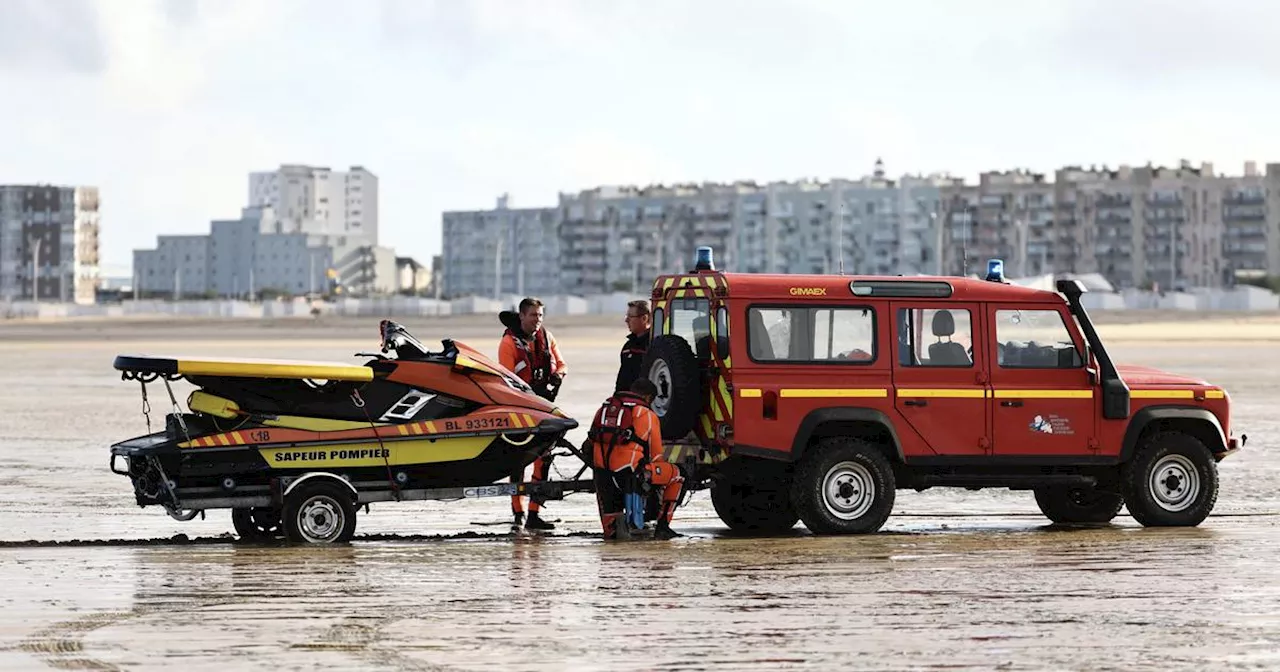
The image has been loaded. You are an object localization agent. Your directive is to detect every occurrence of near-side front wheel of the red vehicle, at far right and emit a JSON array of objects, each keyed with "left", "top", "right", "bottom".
[{"left": 1120, "top": 431, "right": 1217, "bottom": 527}]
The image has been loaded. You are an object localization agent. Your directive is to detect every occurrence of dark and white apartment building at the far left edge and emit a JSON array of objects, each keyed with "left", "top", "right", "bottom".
[{"left": 0, "top": 184, "right": 100, "bottom": 299}]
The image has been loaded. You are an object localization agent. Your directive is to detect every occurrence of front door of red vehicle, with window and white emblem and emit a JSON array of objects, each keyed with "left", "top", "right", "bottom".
[{"left": 987, "top": 305, "right": 1098, "bottom": 456}]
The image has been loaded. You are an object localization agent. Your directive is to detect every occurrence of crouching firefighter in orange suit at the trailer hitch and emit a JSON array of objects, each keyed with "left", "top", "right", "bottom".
[{"left": 588, "top": 378, "right": 685, "bottom": 539}]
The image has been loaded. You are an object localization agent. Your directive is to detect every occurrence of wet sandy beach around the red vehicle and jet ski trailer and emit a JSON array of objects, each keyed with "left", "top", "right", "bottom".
[{"left": 0, "top": 317, "right": 1280, "bottom": 669}]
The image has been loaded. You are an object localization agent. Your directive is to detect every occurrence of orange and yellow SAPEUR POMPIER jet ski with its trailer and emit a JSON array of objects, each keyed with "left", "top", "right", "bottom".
[{"left": 111, "top": 320, "right": 585, "bottom": 543}]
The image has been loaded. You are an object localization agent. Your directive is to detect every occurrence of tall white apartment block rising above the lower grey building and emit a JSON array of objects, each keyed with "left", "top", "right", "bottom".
[{"left": 248, "top": 164, "right": 378, "bottom": 246}]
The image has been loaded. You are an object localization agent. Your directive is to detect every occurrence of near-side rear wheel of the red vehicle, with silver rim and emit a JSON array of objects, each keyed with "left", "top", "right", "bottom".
[{"left": 791, "top": 436, "right": 896, "bottom": 534}]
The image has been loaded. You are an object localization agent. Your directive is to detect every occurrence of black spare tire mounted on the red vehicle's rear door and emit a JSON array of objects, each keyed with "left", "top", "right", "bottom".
[{"left": 640, "top": 334, "right": 707, "bottom": 440}]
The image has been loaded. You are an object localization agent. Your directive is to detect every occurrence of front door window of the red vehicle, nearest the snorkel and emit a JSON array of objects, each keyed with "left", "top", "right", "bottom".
[{"left": 996, "top": 310, "right": 1084, "bottom": 369}]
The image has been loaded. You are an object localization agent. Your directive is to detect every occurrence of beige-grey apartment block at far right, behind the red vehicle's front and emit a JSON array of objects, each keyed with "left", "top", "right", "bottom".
[{"left": 943, "top": 161, "right": 1280, "bottom": 289}]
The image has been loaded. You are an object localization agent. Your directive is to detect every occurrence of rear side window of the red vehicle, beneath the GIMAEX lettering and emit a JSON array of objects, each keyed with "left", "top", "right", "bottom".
[{"left": 746, "top": 306, "right": 876, "bottom": 364}]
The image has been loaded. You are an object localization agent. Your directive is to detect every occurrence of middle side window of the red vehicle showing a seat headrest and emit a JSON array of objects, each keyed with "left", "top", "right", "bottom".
[{"left": 897, "top": 308, "right": 973, "bottom": 367}]
